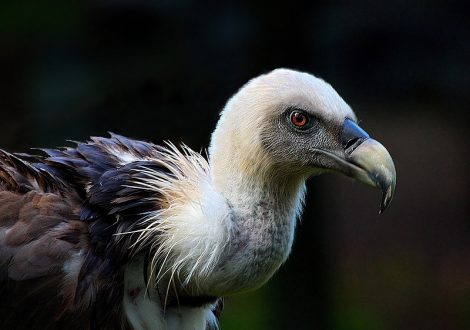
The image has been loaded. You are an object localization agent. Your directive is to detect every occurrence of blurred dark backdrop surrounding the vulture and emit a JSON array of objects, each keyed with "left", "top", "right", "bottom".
[{"left": 0, "top": 0, "right": 470, "bottom": 330}]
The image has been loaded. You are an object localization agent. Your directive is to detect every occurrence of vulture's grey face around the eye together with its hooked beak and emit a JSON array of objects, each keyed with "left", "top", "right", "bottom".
[{"left": 263, "top": 103, "right": 396, "bottom": 212}]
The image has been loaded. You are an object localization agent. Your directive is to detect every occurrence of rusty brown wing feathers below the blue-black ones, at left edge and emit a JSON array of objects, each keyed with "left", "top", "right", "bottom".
[{"left": 0, "top": 191, "right": 87, "bottom": 329}]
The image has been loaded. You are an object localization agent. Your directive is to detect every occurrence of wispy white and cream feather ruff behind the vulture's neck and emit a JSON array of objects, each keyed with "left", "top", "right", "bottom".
[{"left": 121, "top": 143, "right": 230, "bottom": 291}]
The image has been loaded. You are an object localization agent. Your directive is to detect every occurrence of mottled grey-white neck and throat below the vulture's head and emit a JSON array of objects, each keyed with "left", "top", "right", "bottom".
[{"left": 206, "top": 173, "right": 305, "bottom": 295}]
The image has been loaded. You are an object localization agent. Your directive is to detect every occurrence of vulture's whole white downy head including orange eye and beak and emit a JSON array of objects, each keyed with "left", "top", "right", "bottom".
[{"left": 209, "top": 69, "right": 396, "bottom": 212}]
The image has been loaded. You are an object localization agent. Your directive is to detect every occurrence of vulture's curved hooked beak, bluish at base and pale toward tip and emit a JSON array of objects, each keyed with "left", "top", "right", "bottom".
[{"left": 341, "top": 119, "right": 396, "bottom": 213}]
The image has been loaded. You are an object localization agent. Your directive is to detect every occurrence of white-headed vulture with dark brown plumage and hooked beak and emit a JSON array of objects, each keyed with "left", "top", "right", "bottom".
[{"left": 0, "top": 69, "right": 396, "bottom": 329}]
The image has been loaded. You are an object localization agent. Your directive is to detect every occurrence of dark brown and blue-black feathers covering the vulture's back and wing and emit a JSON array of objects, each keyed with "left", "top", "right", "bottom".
[{"left": 0, "top": 134, "right": 172, "bottom": 329}]
